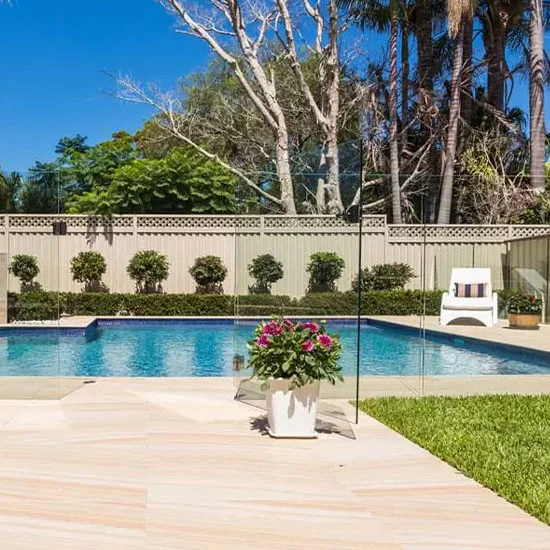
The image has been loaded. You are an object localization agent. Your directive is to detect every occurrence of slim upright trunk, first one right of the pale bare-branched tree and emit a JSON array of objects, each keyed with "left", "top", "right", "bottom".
[{"left": 389, "top": 0, "right": 402, "bottom": 223}]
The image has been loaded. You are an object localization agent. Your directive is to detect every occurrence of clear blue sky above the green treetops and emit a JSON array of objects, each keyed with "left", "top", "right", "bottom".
[{"left": 0, "top": 0, "right": 550, "bottom": 171}]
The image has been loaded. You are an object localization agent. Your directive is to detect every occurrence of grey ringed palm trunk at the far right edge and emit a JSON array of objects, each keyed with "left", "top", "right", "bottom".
[{"left": 529, "top": 0, "right": 545, "bottom": 193}]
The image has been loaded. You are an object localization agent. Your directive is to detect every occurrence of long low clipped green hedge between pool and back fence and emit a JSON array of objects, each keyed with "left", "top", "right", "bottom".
[{"left": 9, "top": 290, "right": 458, "bottom": 321}]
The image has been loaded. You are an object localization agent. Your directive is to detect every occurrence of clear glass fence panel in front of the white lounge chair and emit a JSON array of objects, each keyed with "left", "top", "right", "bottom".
[{"left": 423, "top": 178, "right": 550, "bottom": 395}]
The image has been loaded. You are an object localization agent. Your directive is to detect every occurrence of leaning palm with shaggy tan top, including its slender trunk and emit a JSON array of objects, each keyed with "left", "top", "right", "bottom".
[{"left": 437, "top": 0, "right": 476, "bottom": 224}]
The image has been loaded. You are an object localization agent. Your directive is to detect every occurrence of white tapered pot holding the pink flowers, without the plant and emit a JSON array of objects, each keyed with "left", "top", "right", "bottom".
[{"left": 266, "top": 378, "right": 319, "bottom": 438}]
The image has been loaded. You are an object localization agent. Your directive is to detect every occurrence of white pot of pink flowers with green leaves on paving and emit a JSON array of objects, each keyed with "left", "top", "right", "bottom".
[{"left": 248, "top": 317, "right": 343, "bottom": 438}]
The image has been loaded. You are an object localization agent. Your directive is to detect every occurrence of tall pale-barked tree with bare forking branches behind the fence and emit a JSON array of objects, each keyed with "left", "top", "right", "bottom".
[{"left": 119, "top": 0, "right": 356, "bottom": 214}]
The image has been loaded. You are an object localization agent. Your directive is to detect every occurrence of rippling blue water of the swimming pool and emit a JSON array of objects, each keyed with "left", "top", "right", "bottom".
[{"left": 0, "top": 320, "right": 550, "bottom": 377}]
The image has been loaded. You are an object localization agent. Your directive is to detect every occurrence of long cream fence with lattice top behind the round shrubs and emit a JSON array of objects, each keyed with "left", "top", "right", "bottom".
[{"left": 0, "top": 214, "right": 550, "bottom": 296}]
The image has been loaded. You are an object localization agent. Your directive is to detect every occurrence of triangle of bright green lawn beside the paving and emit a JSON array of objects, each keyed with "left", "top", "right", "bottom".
[{"left": 360, "top": 395, "right": 550, "bottom": 524}]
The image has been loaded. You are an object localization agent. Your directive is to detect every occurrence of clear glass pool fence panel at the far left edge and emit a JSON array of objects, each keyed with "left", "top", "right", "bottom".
[{"left": 0, "top": 171, "right": 62, "bottom": 399}]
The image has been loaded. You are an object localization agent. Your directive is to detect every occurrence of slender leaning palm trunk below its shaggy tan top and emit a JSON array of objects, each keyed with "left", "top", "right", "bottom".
[{"left": 437, "top": 18, "right": 465, "bottom": 224}]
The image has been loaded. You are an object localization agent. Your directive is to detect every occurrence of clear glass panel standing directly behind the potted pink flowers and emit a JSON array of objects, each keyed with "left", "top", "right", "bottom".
[{"left": 235, "top": 142, "right": 366, "bottom": 433}]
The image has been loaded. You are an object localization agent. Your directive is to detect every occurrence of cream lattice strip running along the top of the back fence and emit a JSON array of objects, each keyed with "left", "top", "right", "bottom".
[{"left": 0, "top": 214, "right": 550, "bottom": 243}]
